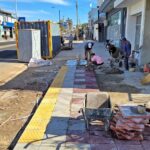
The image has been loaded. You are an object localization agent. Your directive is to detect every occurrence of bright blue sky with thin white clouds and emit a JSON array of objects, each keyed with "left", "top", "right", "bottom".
[{"left": 0, "top": 0, "right": 96, "bottom": 24}]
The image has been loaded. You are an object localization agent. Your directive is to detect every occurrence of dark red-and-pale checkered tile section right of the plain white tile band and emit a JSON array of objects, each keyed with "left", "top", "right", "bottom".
[{"left": 66, "top": 66, "right": 150, "bottom": 150}]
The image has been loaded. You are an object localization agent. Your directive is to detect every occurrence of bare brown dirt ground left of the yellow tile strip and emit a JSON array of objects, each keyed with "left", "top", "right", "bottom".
[{"left": 0, "top": 60, "right": 65, "bottom": 150}]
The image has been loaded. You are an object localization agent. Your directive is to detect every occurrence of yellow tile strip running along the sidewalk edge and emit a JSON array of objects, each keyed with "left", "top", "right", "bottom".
[{"left": 19, "top": 66, "right": 67, "bottom": 143}]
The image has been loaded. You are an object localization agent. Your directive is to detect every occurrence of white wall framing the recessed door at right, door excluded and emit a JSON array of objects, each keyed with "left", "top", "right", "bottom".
[{"left": 126, "top": 0, "right": 145, "bottom": 49}]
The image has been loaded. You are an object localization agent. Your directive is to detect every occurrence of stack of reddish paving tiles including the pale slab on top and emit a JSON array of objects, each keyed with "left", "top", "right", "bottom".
[{"left": 110, "top": 106, "right": 150, "bottom": 141}]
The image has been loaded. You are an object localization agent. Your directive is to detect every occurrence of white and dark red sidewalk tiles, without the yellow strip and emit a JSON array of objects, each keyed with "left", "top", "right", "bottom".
[{"left": 15, "top": 65, "right": 150, "bottom": 150}]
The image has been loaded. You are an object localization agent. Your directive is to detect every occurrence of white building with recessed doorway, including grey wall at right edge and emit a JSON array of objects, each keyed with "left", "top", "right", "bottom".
[{"left": 114, "top": 0, "right": 150, "bottom": 65}]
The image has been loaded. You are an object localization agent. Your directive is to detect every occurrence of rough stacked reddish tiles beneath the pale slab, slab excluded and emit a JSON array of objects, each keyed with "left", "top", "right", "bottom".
[{"left": 110, "top": 105, "right": 148, "bottom": 141}]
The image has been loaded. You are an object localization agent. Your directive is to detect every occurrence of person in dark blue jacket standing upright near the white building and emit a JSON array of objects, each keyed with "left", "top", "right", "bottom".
[{"left": 121, "top": 38, "right": 131, "bottom": 70}]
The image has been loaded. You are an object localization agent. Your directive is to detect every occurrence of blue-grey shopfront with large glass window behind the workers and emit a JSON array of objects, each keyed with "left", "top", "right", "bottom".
[{"left": 100, "top": 0, "right": 127, "bottom": 47}]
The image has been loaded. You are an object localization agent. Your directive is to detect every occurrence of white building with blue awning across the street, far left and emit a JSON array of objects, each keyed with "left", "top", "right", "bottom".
[{"left": 0, "top": 9, "right": 16, "bottom": 38}]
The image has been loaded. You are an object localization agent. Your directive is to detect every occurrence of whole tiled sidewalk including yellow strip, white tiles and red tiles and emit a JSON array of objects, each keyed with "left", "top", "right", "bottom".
[{"left": 15, "top": 41, "right": 150, "bottom": 150}]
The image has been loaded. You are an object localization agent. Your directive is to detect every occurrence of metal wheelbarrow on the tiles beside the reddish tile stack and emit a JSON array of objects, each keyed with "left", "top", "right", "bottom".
[{"left": 80, "top": 92, "right": 112, "bottom": 131}]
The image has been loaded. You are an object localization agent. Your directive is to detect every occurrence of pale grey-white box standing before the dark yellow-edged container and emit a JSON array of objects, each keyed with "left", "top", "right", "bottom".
[{"left": 18, "top": 29, "right": 41, "bottom": 62}]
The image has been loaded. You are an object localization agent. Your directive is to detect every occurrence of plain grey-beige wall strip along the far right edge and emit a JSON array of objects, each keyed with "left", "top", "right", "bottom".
[{"left": 141, "top": 0, "right": 150, "bottom": 65}]
